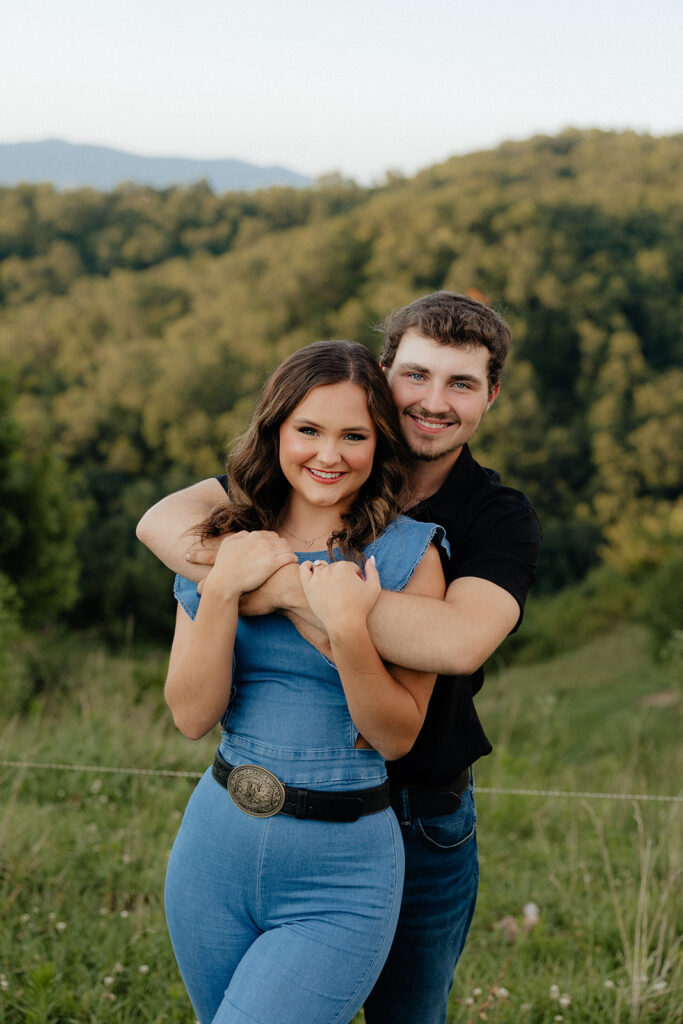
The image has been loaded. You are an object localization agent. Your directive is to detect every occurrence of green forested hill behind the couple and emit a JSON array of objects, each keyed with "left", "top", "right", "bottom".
[{"left": 0, "top": 131, "right": 683, "bottom": 630}]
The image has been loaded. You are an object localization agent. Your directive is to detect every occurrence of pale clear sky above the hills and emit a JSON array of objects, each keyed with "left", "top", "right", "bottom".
[{"left": 0, "top": 0, "right": 683, "bottom": 184}]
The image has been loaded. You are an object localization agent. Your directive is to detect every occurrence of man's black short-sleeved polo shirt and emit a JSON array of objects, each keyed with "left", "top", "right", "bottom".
[{"left": 387, "top": 444, "right": 541, "bottom": 785}]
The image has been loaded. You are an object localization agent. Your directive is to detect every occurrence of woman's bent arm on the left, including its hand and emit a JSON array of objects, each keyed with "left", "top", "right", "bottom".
[{"left": 164, "top": 530, "right": 296, "bottom": 739}]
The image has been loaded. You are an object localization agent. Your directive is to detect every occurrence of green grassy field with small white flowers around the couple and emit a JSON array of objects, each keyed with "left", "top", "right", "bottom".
[{"left": 0, "top": 627, "right": 682, "bottom": 1024}]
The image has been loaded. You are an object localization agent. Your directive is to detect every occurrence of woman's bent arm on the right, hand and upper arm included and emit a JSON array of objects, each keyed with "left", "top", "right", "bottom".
[{"left": 301, "top": 545, "right": 445, "bottom": 761}]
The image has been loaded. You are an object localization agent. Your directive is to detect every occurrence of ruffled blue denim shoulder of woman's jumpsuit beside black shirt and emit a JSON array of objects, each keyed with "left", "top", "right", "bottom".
[{"left": 364, "top": 515, "right": 449, "bottom": 590}]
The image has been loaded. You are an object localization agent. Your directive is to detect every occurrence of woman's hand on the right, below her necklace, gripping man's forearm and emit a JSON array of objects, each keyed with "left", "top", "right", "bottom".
[{"left": 299, "top": 557, "right": 382, "bottom": 636}]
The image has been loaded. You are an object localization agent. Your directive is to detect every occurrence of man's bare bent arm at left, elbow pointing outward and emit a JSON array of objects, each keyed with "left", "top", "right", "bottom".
[{"left": 136, "top": 479, "right": 225, "bottom": 583}]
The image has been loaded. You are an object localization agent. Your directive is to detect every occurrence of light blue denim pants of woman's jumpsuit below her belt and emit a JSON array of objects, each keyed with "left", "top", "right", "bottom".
[{"left": 165, "top": 771, "right": 403, "bottom": 1024}]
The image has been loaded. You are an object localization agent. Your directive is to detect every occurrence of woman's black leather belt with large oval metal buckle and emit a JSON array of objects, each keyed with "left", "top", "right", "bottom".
[{"left": 211, "top": 754, "right": 389, "bottom": 821}]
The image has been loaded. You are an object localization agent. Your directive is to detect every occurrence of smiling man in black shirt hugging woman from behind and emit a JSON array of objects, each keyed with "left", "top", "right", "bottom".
[{"left": 138, "top": 292, "right": 540, "bottom": 1024}]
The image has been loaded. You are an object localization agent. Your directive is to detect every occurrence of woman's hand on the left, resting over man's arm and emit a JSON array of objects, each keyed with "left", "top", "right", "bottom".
[{"left": 203, "top": 529, "right": 297, "bottom": 598}]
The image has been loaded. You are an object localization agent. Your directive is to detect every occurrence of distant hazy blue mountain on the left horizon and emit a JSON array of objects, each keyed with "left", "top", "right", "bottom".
[{"left": 0, "top": 139, "right": 311, "bottom": 193}]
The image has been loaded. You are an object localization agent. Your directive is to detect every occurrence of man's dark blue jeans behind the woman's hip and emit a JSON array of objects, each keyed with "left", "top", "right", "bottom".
[{"left": 365, "top": 786, "right": 479, "bottom": 1024}]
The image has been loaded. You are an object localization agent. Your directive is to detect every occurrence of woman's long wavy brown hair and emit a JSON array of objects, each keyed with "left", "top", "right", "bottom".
[{"left": 199, "top": 341, "right": 405, "bottom": 561}]
